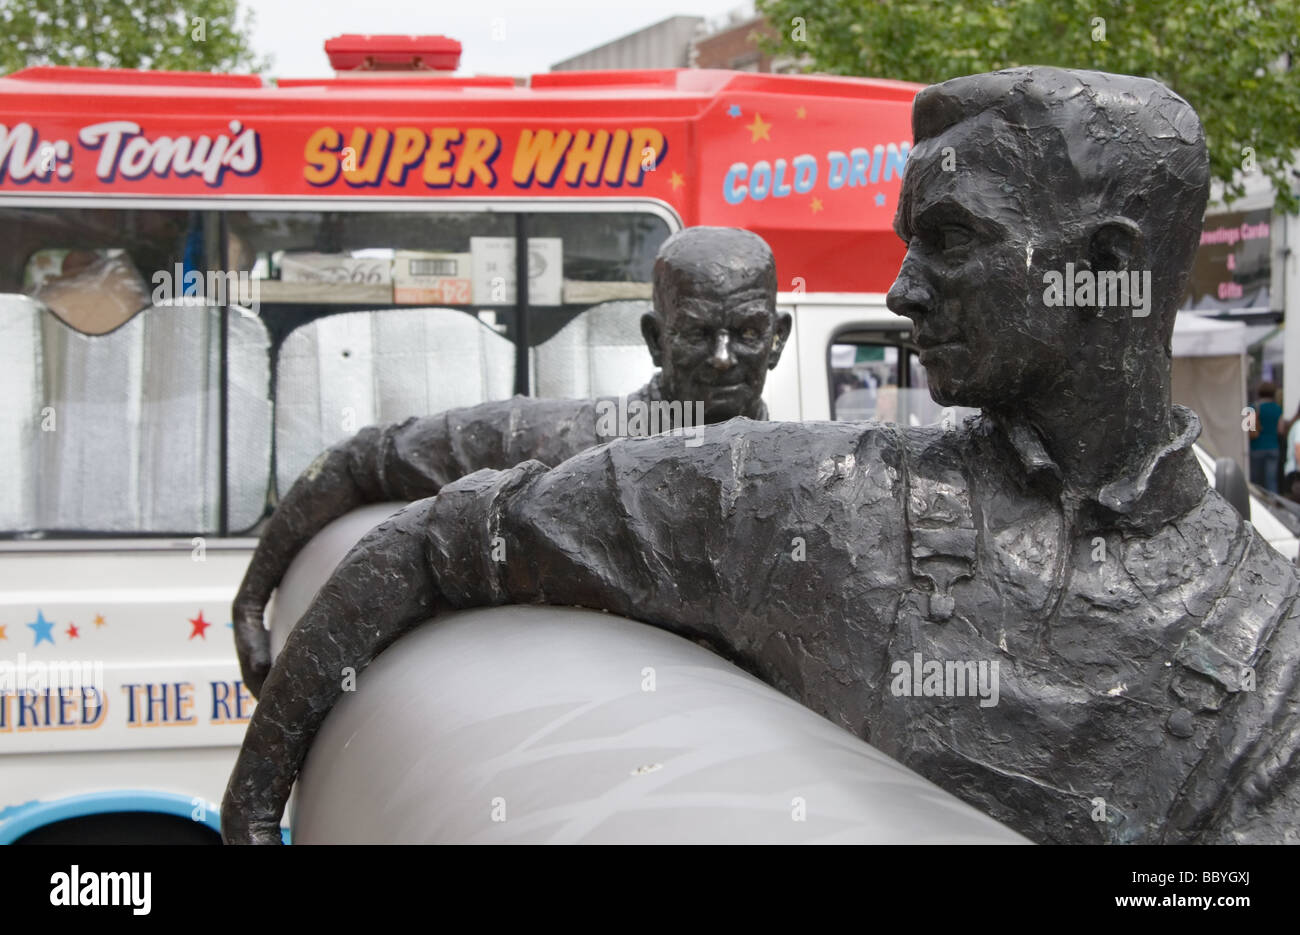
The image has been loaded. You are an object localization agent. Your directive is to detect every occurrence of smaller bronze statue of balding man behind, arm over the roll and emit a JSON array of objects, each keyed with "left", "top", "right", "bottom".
[{"left": 234, "top": 228, "right": 790, "bottom": 697}]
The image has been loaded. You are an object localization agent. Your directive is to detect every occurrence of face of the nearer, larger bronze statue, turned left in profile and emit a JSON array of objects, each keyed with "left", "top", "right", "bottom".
[{"left": 887, "top": 116, "right": 1080, "bottom": 410}]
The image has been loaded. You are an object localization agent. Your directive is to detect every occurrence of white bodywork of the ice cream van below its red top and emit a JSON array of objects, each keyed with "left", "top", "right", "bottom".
[{"left": 0, "top": 283, "right": 1297, "bottom": 843}]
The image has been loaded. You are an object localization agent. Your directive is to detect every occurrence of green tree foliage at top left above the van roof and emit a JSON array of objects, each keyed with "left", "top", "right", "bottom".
[{"left": 0, "top": 0, "right": 269, "bottom": 72}]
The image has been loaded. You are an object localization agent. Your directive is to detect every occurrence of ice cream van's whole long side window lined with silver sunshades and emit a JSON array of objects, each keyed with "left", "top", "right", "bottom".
[{"left": 0, "top": 207, "right": 671, "bottom": 537}]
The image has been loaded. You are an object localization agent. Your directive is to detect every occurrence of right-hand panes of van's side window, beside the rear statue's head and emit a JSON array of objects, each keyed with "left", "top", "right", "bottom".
[{"left": 226, "top": 211, "right": 671, "bottom": 492}]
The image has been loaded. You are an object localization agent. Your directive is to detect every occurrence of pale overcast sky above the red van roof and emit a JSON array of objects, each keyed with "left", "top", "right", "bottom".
[{"left": 242, "top": 0, "right": 745, "bottom": 78}]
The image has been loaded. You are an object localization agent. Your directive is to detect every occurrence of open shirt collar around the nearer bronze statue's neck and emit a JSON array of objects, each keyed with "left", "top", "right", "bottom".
[{"left": 992, "top": 403, "right": 1205, "bottom": 527}]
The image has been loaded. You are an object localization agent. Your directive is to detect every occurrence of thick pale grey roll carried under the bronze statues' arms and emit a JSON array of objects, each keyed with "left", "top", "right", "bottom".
[{"left": 272, "top": 503, "right": 1024, "bottom": 844}]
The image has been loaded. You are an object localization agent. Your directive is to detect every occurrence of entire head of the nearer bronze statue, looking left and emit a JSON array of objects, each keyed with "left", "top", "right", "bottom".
[{"left": 888, "top": 66, "right": 1209, "bottom": 410}]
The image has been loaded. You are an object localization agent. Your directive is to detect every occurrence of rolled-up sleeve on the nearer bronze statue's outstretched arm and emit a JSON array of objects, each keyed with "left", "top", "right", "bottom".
[{"left": 429, "top": 419, "right": 907, "bottom": 731}]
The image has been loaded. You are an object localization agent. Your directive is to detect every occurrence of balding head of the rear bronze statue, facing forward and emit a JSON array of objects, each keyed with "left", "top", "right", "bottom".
[{"left": 641, "top": 228, "right": 790, "bottom": 423}]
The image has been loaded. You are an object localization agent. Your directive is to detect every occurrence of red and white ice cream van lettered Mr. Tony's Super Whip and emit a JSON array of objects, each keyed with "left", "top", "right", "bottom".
[{"left": 0, "top": 36, "right": 1296, "bottom": 843}]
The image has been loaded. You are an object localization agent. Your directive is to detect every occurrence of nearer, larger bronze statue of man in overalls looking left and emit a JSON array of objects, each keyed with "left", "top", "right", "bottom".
[{"left": 222, "top": 68, "right": 1300, "bottom": 843}]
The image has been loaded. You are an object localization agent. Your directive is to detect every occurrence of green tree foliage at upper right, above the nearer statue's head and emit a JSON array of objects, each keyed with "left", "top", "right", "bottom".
[{"left": 758, "top": 0, "right": 1300, "bottom": 211}]
